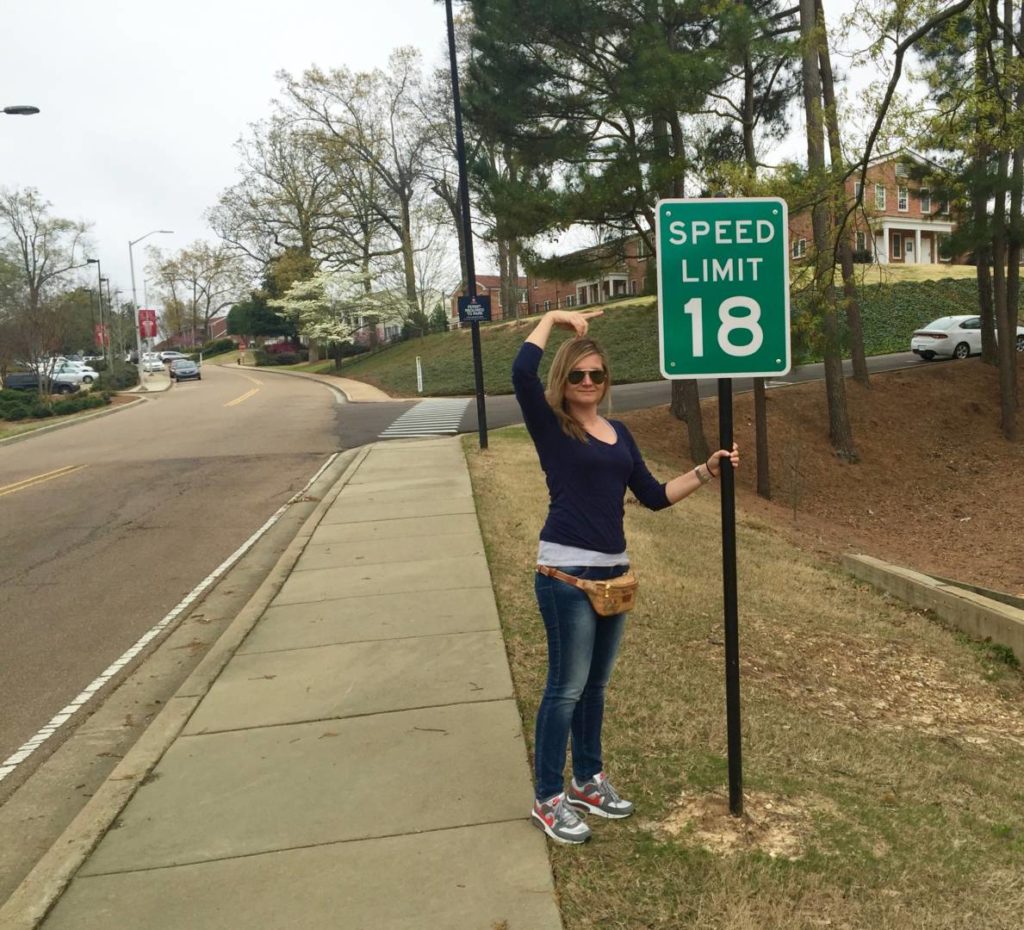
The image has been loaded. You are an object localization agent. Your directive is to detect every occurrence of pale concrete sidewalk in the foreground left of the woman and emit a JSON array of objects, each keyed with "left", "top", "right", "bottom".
[{"left": 9, "top": 438, "right": 561, "bottom": 930}]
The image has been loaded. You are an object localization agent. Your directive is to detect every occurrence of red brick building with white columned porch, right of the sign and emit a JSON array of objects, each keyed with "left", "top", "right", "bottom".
[{"left": 790, "top": 150, "right": 956, "bottom": 264}]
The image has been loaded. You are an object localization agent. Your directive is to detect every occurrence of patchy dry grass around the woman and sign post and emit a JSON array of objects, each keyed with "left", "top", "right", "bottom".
[{"left": 465, "top": 428, "right": 1024, "bottom": 930}]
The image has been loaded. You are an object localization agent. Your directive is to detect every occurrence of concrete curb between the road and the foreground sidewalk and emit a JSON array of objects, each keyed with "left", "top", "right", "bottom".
[{"left": 0, "top": 442, "right": 373, "bottom": 930}]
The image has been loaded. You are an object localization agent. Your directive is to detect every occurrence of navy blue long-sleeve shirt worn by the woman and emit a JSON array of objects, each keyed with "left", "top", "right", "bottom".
[{"left": 512, "top": 342, "right": 670, "bottom": 553}]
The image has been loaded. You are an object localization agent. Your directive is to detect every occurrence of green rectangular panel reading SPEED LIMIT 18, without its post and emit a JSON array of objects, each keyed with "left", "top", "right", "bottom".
[{"left": 657, "top": 197, "right": 790, "bottom": 378}]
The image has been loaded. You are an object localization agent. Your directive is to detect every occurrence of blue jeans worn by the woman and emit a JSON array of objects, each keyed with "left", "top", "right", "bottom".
[{"left": 534, "top": 565, "right": 629, "bottom": 801}]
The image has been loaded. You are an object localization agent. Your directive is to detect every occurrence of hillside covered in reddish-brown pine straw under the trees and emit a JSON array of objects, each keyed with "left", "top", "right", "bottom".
[{"left": 623, "top": 355, "right": 1024, "bottom": 595}]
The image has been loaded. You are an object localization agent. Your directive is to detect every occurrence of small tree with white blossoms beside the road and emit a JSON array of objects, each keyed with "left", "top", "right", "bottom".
[{"left": 267, "top": 270, "right": 410, "bottom": 365}]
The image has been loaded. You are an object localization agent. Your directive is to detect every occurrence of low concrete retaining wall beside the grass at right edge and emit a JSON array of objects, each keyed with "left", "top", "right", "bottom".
[{"left": 843, "top": 555, "right": 1024, "bottom": 663}]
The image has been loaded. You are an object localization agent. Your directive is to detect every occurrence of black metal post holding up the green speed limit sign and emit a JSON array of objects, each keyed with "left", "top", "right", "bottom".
[{"left": 718, "top": 378, "right": 743, "bottom": 816}]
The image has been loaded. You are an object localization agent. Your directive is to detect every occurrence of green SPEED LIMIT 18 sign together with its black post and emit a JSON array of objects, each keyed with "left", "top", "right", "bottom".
[{"left": 656, "top": 197, "right": 792, "bottom": 816}]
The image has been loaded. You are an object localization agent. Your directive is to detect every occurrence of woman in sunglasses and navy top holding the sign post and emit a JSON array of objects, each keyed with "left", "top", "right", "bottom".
[{"left": 512, "top": 310, "right": 739, "bottom": 843}]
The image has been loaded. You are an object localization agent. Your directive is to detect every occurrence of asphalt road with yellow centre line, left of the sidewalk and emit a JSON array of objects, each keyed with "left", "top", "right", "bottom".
[{"left": 0, "top": 366, "right": 341, "bottom": 761}]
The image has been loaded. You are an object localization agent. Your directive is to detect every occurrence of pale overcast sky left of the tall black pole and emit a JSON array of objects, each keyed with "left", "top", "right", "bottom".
[{"left": 0, "top": 0, "right": 447, "bottom": 302}]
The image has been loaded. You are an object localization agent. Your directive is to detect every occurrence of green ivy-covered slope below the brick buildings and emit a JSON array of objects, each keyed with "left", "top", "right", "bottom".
[{"left": 341, "top": 279, "right": 1015, "bottom": 396}]
